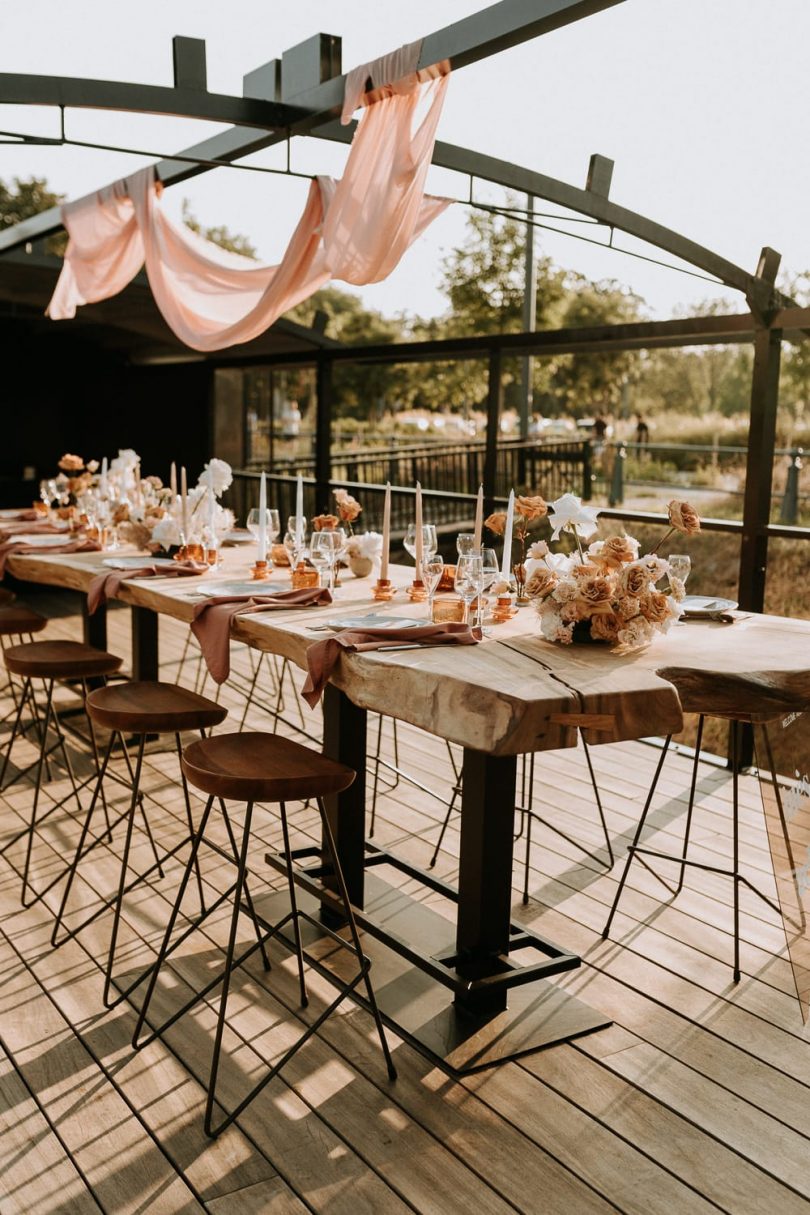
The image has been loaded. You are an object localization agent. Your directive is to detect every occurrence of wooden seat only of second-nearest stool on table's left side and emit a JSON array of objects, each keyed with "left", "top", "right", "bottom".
[{"left": 87, "top": 679, "right": 228, "bottom": 734}]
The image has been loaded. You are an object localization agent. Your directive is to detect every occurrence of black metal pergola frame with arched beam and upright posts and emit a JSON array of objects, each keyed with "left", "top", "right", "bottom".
[{"left": 0, "top": 0, "right": 810, "bottom": 610}]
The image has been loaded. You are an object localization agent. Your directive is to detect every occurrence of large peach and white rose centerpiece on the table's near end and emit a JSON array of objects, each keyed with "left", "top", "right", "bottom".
[{"left": 526, "top": 493, "right": 701, "bottom": 652}]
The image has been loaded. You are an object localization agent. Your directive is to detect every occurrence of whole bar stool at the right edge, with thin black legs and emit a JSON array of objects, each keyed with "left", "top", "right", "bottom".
[{"left": 602, "top": 667, "right": 810, "bottom": 983}]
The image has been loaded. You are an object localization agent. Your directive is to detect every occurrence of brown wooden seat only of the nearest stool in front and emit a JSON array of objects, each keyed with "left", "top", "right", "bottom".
[{"left": 183, "top": 733, "right": 355, "bottom": 802}]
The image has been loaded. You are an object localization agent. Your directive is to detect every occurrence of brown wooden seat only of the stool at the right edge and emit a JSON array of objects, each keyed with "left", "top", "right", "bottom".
[{"left": 656, "top": 667, "right": 810, "bottom": 722}]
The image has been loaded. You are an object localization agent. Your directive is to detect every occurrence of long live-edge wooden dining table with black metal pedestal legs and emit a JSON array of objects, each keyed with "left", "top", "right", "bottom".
[{"left": 9, "top": 550, "right": 810, "bottom": 1072}]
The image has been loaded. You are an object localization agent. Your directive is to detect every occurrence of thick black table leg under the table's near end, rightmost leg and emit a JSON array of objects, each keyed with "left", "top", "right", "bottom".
[{"left": 455, "top": 748, "right": 517, "bottom": 1015}]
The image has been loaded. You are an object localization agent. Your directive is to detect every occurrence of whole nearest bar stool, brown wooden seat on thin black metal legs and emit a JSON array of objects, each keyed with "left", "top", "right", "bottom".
[{"left": 132, "top": 733, "right": 396, "bottom": 1136}]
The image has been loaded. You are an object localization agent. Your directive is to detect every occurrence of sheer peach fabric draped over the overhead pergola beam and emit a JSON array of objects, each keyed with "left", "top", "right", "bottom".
[{"left": 47, "top": 49, "right": 449, "bottom": 351}]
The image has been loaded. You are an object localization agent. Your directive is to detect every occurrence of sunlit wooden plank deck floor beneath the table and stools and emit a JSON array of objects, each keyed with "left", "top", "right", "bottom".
[{"left": 0, "top": 594, "right": 810, "bottom": 1215}]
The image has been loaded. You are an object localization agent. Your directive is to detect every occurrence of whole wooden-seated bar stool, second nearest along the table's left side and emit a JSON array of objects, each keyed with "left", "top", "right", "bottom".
[{"left": 51, "top": 680, "right": 228, "bottom": 1007}]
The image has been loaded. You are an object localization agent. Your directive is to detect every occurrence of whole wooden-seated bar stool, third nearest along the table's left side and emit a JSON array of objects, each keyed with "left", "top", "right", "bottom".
[{"left": 0, "top": 642, "right": 123, "bottom": 906}]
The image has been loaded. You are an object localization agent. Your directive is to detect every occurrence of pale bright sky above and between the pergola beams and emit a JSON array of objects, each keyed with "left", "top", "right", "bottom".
[{"left": 0, "top": 0, "right": 810, "bottom": 318}]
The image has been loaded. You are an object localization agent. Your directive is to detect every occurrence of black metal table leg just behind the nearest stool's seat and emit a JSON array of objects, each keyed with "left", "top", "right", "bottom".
[{"left": 323, "top": 684, "right": 367, "bottom": 920}]
